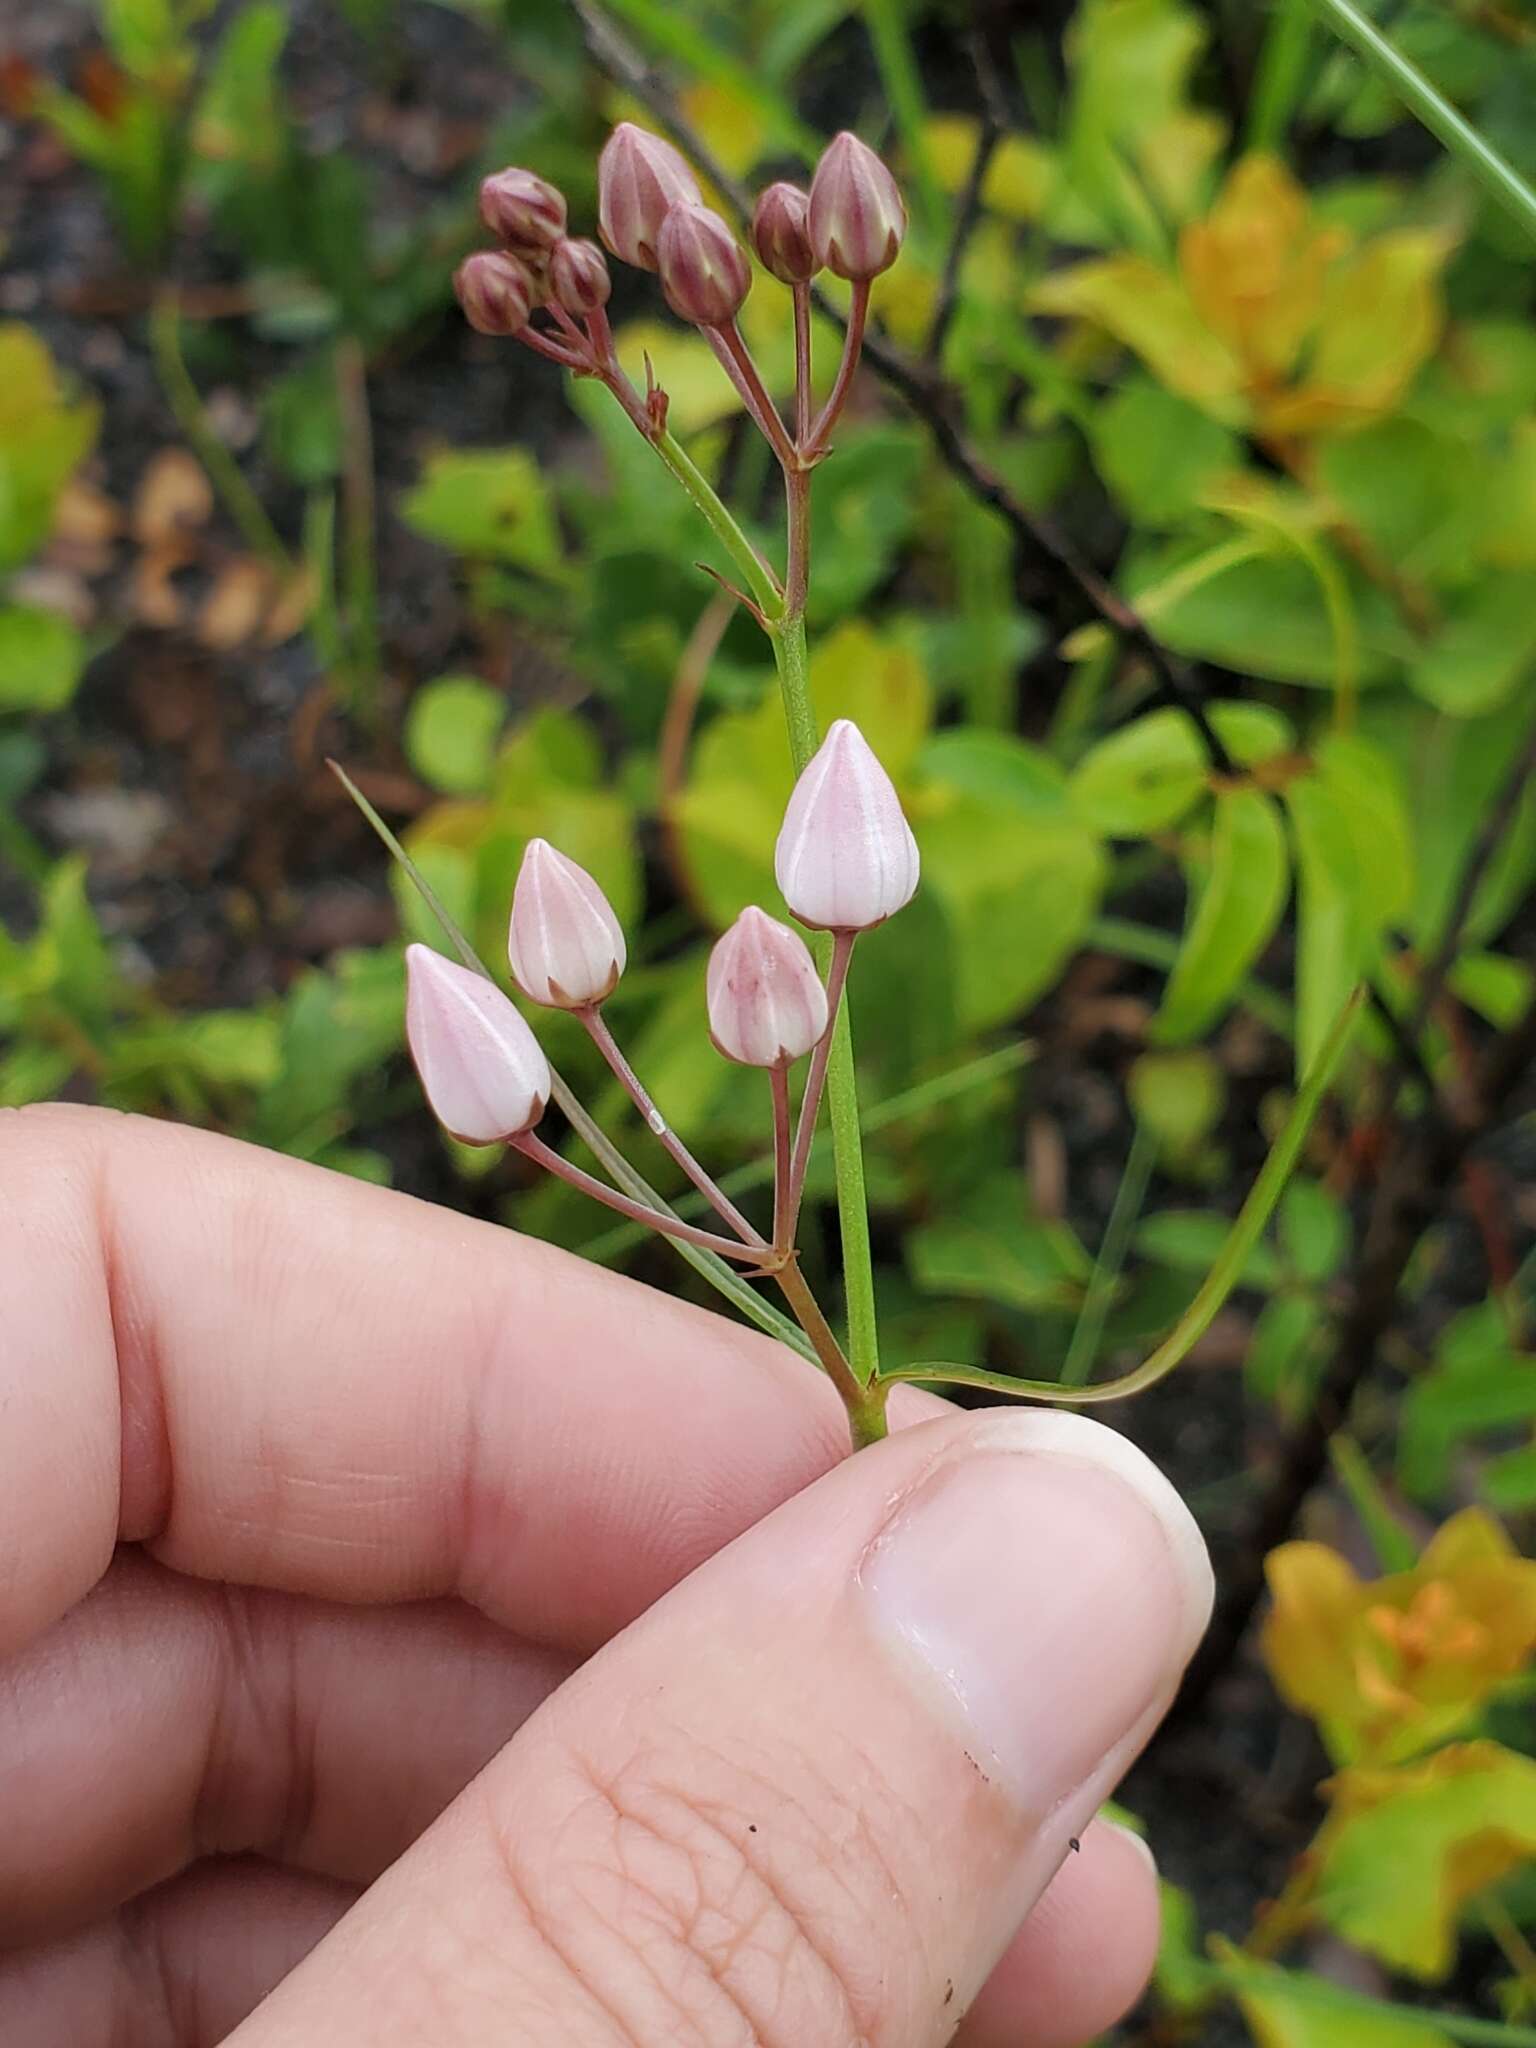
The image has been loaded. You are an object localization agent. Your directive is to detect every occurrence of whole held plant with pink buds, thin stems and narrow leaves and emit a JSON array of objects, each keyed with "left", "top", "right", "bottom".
[{"left": 348, "top": 123, "right": 1354, "bottom": 1448}]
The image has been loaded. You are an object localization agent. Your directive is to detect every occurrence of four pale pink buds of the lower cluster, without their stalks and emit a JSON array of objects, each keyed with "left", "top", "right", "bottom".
[{"left": 406, "top": 719, "right": 918, "bottom": 1145}]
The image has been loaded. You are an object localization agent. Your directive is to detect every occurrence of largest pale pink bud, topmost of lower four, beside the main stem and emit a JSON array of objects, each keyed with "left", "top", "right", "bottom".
[{"left": 774, "top": 719, "right": 918, "bottom": 932}]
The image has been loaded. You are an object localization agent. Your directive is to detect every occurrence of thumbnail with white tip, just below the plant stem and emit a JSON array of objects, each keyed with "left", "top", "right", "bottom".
[{"left": 858, "top": 1411, "right": 1212, "bottom": 1817}]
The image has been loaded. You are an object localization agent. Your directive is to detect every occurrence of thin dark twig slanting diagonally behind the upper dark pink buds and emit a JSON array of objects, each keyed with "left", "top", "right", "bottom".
[{"left": 571, "top": 0, "right": 1237, "bottom": 774}]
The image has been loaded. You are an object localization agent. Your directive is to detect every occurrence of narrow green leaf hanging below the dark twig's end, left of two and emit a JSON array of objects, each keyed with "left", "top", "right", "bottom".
[{"left": 1153, "top": 788, "right": 1290, "bottom": 1044}]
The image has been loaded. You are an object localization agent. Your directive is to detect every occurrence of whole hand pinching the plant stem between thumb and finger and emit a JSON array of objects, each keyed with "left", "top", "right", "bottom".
[{"left": 0, "top": 1108, "right": 1210, "bottom": 2048}]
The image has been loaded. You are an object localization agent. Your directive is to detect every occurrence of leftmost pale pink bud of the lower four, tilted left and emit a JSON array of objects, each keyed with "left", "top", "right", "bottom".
[{"left": 406, "top": 946, "right": 549, "bottom": 1145}]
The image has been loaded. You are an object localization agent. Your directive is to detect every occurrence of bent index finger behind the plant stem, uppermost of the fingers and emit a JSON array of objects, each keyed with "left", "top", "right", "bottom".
[{"left": 0, "top": 1106, "right": 846, "bottom": 1651}]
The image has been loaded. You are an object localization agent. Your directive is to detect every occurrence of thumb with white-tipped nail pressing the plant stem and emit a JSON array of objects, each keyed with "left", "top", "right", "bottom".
[{"left": 233, "top": 1411, "right": 1210, "bottom": 2048}]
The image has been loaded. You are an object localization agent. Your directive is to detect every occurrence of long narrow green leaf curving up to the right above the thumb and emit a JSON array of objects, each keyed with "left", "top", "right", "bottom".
[{"left": 881, "top": 989, "right": 1364, "bottom": 1407}]
